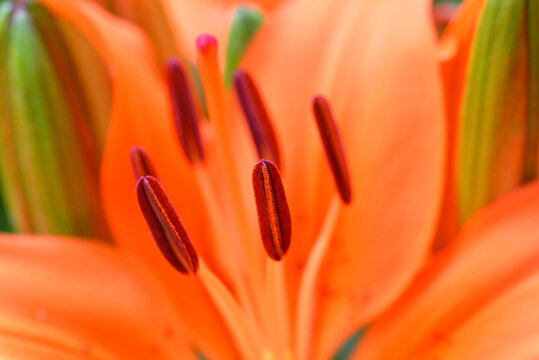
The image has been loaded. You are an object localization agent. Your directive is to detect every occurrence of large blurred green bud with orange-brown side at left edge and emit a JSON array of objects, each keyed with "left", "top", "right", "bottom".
[{"left": 0, "top": 1, "right": 111, "bottom": 237}]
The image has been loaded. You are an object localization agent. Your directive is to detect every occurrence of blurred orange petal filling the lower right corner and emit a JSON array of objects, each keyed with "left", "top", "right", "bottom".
[{"left": 356, "top": 183, "right": 539, "bottom": 360}]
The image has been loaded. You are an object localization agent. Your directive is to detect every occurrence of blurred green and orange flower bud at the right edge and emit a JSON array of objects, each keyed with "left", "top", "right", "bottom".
[{"left": 457, "top": 0, "right": 539, "bottom": 223}]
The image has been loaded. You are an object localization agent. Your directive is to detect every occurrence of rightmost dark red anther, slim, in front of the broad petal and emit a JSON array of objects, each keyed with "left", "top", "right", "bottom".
[{"left": 313, "top": 95, "right": 352, "bottom": 204}]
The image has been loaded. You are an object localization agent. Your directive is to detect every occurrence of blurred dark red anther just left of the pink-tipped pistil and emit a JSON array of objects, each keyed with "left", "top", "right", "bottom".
[{"left": 166, "top": 59, "right": 204, "bottom": 164}]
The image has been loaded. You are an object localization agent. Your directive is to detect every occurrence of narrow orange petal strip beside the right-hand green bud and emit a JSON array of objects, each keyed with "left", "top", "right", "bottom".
[{"left": 434, "top": 0, "right": 486, "bottom": 251}]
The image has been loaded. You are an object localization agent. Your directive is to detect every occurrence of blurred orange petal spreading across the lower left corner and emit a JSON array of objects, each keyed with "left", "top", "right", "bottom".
[{"left": 0, "top": 234, "right": 194, "bottom": 359}]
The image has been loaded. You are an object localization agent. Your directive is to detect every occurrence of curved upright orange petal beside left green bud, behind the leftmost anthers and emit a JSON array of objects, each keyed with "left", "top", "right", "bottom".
[{"left": 39, "top": 0, "right": 236, "bottom": 358}]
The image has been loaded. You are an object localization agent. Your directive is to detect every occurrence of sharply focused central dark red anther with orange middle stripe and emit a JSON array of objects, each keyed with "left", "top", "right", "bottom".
[{"left": 253, "top": 160, "right": 292, "bottom": 261}]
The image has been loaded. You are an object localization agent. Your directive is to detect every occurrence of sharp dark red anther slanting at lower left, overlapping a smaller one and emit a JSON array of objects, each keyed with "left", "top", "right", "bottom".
[{"left": 137, "top": 176, "right": 198, "bottom": 274}]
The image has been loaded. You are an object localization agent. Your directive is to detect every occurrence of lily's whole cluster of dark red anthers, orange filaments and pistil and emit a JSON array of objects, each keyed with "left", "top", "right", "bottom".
[{"left": 131, "top": 35, "right": 352, "bottom": 360}]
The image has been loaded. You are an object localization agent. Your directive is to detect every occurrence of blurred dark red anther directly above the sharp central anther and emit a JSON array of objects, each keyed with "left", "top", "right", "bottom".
[{"left": 234, "top": 70, "right": 281, "bottom": 168}]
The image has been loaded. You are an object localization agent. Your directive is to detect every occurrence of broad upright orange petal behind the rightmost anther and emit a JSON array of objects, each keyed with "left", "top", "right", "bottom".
[{"left": 246, "top": 0, "right": 445, "bottom": 358}]
